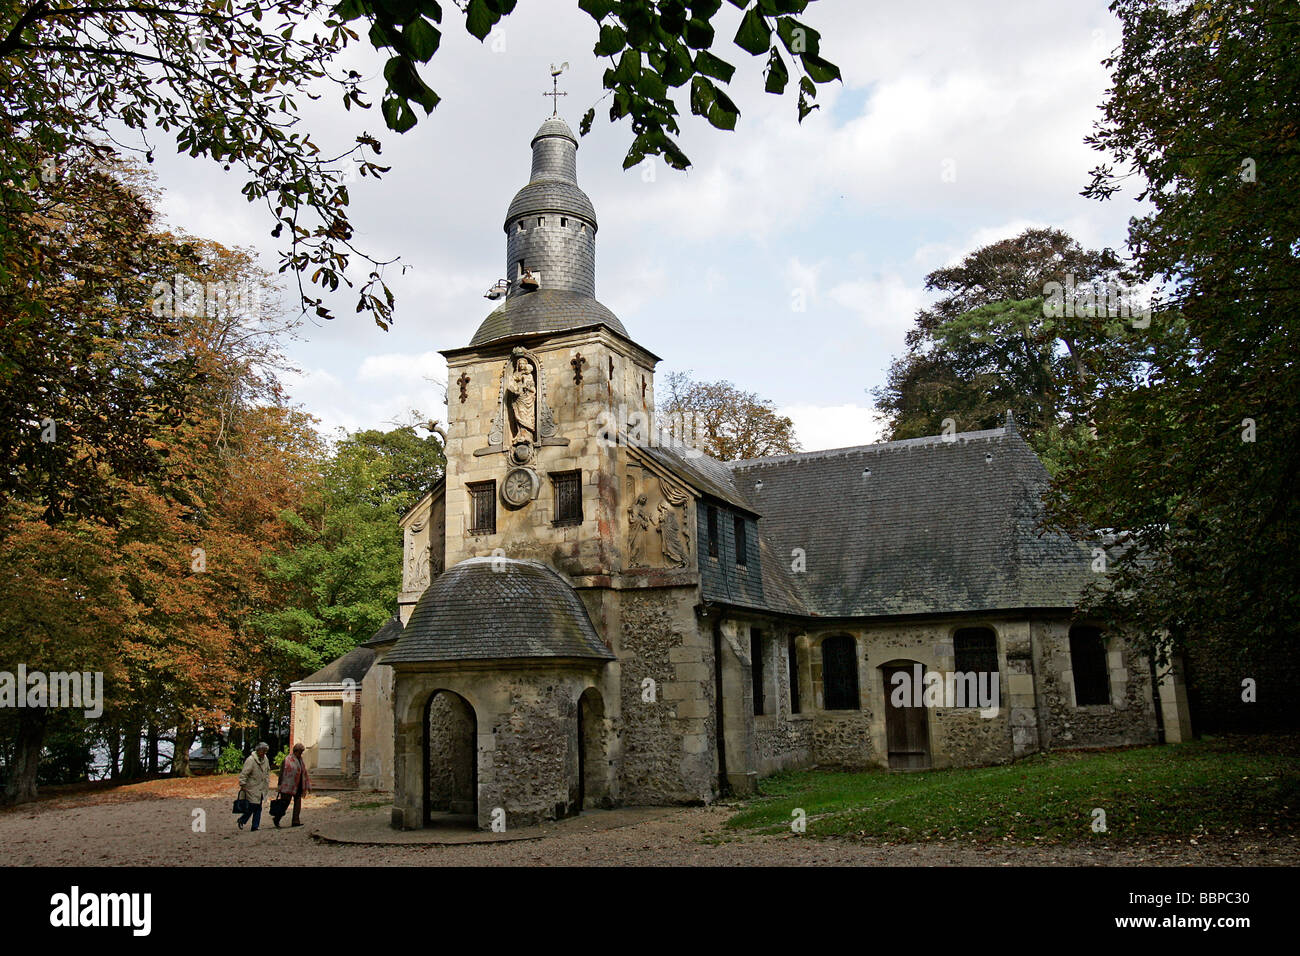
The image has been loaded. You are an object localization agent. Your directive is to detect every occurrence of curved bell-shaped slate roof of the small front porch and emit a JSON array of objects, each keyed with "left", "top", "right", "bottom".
[{"left": 382, "top": 558, "right": 614, "bottom": 663}]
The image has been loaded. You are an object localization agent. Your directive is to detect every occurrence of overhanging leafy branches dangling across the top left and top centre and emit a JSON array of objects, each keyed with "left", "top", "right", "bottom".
[{"left": 0, "top": 0, "right": 840, "bottom": 328}]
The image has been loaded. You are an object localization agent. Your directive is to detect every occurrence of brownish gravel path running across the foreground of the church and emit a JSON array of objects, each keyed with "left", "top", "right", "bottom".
[{"left": 0, "top": 777, "right": 1300, "bottom": 866}]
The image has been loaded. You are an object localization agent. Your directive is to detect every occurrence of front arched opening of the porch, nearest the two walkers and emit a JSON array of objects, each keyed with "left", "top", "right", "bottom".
[{"left": 424, "top": 691, "right": 478, "bottom": 826}]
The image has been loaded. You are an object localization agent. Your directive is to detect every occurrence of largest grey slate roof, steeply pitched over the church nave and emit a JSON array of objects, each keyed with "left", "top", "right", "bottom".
[{"left": 728, "top": 425, "right": 1091, "bottom": 618}]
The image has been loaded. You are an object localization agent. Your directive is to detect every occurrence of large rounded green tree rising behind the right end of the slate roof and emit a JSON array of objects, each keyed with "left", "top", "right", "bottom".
[{"left": 875, "top": 229, "right": 1147, "bottom": 470}]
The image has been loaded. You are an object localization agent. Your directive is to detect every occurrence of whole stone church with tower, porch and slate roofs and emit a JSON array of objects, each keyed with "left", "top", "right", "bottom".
[{"left": 291, "top": 111, "right": 1188, "bottom": 829}]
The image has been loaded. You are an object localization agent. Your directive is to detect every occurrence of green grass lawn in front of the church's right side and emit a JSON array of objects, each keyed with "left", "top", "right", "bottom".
[{"left": 727, "top": 737, "right": 1300, "bottom": 843}]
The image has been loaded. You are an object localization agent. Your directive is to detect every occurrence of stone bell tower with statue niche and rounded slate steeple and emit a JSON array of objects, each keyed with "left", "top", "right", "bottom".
[{"left": 443, "top": 116, "right": 659, "bottom": 581}]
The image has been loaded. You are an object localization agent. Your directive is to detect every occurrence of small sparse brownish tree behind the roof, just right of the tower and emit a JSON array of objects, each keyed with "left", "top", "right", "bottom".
[{"left": 658, "top": 372, "right": 800, "bottom": 462}]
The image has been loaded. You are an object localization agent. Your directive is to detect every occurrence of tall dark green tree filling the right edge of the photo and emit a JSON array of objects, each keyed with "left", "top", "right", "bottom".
[{"left": 1049, "top": 0, "right": 1300, "bottom": 721}]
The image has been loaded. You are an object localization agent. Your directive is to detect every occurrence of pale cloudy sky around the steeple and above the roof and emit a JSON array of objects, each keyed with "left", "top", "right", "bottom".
[{"left": 139, "top": 0, "right": 1135, "bottom": 450}]
